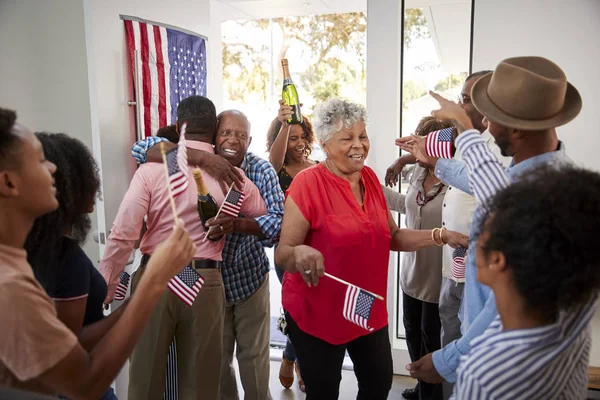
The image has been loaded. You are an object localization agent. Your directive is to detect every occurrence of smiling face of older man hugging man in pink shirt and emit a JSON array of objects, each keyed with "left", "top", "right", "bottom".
[{"left": 215, "top": 113, "right": 252, "bottom": 167}]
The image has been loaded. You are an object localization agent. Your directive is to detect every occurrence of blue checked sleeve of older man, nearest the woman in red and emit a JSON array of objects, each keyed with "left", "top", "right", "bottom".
[{"left": 254, "top": 163, "right": 284, "bottom": 247}]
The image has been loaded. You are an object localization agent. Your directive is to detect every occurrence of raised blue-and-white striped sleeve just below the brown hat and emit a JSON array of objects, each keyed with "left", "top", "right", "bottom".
[{"left": 458, "top": 129, "right": 510, "bottom": 207}]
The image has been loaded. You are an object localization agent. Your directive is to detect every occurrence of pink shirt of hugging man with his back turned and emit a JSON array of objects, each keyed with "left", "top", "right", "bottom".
[{"left": 99, "top": 140, "right": 266, "bottom": 298}]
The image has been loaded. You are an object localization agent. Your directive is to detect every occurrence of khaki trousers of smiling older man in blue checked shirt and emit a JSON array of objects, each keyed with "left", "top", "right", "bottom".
[{"left": 221, "top": 274, "right": 271, "bottom": 400}]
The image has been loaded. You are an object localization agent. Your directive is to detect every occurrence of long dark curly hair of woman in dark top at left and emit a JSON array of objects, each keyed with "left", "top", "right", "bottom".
[{"left": 25, "top": 132, "right": 100, "bottom": 287}]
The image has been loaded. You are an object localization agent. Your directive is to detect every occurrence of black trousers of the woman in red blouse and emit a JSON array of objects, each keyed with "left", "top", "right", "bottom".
[{"left": 286, "top": 313, "right": 393, "bottom": 400}]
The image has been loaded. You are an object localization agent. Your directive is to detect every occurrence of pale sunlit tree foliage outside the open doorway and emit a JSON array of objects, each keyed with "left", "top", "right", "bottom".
[{"left": 223, "top": 9, "right": 429, "bottom": 102}]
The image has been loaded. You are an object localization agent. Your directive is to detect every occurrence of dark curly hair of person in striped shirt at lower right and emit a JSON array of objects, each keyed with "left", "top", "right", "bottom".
[{"left": 481, "top": 167, "right": 600, "bottom": 320}]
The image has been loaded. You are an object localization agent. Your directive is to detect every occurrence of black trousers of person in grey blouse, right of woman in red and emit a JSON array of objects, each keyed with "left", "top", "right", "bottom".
[{"left": 402, "top": 292, "right": 442, "bottom": 400}]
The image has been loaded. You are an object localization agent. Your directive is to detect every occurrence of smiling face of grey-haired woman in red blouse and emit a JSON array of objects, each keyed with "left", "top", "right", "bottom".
[{"left": 323, "top": 121, "right": 370, "bottom": 174}]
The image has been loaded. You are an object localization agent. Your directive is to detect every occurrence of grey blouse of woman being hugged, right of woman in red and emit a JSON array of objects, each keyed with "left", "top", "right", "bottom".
[{"left": 383, "top": 165, "right": 447, "bottom": 304}]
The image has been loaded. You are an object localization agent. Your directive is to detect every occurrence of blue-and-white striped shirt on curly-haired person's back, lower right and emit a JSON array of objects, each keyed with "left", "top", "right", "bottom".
[{"left": 453, "top": 297, "right": 596, "bottom": 400}]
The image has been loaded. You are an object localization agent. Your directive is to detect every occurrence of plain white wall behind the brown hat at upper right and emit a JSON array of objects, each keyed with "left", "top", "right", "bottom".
[{"left": 473, "top": 0, "right": 600, "bottom": 366}]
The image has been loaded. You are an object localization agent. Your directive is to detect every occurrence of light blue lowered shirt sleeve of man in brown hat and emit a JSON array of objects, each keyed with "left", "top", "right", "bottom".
[{"left": 433, "top": 292, "right": 498, "bottom": 382}]
